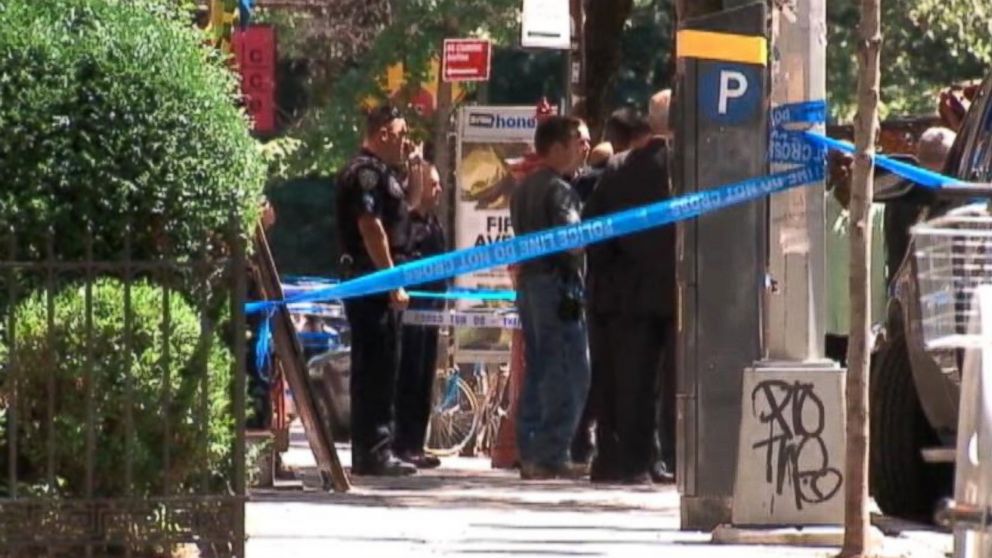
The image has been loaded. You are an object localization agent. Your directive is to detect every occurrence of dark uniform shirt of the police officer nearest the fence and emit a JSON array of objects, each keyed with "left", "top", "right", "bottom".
[{"left": 337, "top": 149, "right": 410, "bottom": 273}]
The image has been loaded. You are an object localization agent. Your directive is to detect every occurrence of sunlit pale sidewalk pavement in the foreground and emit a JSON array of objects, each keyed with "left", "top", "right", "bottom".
[{"left": 247, "top": 431, "right": 951, "bottom": 558}]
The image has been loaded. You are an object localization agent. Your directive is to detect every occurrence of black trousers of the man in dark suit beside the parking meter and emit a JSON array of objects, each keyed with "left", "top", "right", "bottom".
[{"left": 590, "top": 314, "right": 670, "bottom": 478}]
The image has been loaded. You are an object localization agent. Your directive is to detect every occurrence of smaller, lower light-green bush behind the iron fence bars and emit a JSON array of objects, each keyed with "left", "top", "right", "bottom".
[{"left": 0, "top": 279, "right": 234, "bottom": 497}]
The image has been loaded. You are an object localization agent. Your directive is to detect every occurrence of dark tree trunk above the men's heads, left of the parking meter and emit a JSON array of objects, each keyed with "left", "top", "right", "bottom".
[{"left": 580, "top": 0, "right": 634, "bottom": 138}]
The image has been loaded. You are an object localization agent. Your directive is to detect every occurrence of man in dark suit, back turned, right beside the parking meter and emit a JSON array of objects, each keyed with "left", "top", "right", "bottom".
[{"left": 583, "top": 103, "right": 675, "bottom": 483}]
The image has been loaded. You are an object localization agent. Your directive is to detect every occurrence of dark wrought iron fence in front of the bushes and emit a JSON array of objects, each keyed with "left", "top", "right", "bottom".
[{"left": 0, "top": 227, "right": 246, "bottom": 558}]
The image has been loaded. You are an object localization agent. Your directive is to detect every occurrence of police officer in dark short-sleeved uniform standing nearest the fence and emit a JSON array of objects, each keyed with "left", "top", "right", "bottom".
[{"left": 337, "top": 106, "right": 416, "bottom": 476}]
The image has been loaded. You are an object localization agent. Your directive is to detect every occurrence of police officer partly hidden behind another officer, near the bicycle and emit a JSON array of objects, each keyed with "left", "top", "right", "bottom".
[{"left": 393, "top": 162, "right": 448, "bottom": 469}]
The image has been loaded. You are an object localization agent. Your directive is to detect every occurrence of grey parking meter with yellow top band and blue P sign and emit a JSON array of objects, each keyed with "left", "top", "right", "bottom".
[{"left": 675, "top": 2, "right": 768, "bottom": 530}]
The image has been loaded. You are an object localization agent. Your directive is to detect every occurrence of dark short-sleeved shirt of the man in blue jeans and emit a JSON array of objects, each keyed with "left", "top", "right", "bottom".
[{"left": 510, "top": 168, "right": 583, "bottom": 280}]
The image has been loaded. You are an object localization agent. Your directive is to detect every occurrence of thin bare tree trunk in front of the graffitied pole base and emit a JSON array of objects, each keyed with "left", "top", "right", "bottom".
[{"left": 841, "top": 0, "right": 882, "bottom": 557}]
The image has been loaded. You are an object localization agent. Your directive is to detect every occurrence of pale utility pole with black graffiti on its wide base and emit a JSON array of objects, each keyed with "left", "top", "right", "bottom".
[{"left": 733, "top": 0, "right": 845, "bottom": 540}]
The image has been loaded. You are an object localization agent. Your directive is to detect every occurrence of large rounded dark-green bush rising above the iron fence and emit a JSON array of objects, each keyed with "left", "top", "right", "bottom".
[{"left": 0, "top": 0, "right": 265, "bottom": 258}]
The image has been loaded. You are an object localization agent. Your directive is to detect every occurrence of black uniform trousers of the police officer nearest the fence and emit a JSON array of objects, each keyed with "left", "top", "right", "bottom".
[{"left": 344, "top": 296, "right": 400, "bottom": 467}]
